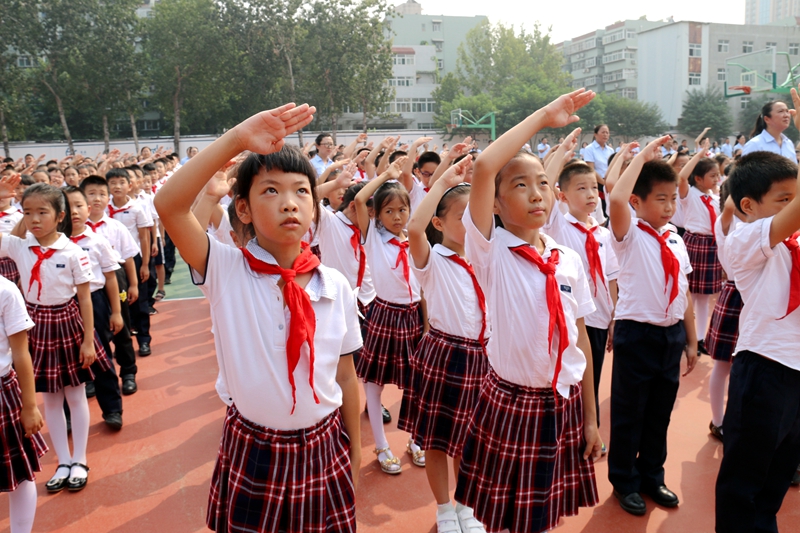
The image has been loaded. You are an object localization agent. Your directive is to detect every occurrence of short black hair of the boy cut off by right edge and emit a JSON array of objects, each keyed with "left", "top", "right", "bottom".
[{"left": 727, "top": 152, "right": 797, "bottom": 212}]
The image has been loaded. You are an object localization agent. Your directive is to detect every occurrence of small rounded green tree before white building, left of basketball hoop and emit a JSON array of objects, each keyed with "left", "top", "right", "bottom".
[{"left": 678, "top": 87, "right": 733, "bottom": 139}]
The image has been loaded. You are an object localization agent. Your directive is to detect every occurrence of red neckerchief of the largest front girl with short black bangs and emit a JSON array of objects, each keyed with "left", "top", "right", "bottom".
[{"left": 240, "top": 243, "right": 320, "bottom": 414}]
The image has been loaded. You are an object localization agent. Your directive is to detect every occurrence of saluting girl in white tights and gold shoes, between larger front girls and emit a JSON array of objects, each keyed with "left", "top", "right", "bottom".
[{"left": 355, "top": 157, "right": 425, "bottom": 474}]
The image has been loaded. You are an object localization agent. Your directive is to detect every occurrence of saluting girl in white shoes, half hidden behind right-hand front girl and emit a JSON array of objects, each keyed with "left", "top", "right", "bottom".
[{"left": 408, "top": 155, "right": 489, "bottom": 533}]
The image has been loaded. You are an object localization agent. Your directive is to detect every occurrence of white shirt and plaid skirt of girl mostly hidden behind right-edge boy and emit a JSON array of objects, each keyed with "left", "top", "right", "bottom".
[{"left": 705, "top": 217, "right": 743, "bottom": 363}]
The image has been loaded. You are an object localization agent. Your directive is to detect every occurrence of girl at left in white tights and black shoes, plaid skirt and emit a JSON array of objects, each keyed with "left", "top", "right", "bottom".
[{"left": 0, "top": 183, "right": 110, "bottom": 492}]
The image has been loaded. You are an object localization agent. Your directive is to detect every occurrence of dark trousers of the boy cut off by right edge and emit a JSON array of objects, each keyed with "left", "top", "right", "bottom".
[{"left": 716, "top": 351, "right": 800, "bottom": 533}]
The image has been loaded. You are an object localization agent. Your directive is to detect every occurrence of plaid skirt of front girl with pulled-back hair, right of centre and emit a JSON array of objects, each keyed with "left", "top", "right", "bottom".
[{"left": 456, "top": 370, "right": 598, "bottom": 533}]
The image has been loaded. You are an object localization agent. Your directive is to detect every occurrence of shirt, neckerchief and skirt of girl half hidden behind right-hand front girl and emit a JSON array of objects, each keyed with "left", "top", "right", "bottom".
[{"left": 411, "top": 244, "right": 491, "bottom": 457}]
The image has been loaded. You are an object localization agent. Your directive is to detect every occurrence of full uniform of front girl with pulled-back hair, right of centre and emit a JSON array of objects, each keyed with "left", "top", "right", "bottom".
[{"left": 455, "top": 206, "right": 598, "bottom": 532}]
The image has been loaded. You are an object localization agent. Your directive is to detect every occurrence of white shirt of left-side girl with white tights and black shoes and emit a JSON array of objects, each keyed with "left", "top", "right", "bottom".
[{"left": 0, "top": 233, "right": 94, "bottom": 305}]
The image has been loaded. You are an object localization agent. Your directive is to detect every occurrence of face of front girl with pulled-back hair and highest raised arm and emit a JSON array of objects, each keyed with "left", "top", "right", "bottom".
[{"left": 494, "top": 156, "right": 554, "bottom": 235}]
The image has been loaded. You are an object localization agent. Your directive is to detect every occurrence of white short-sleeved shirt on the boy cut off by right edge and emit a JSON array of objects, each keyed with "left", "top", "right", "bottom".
[{"left": 726, "top": 217, "right": 800, "bottom": 370}]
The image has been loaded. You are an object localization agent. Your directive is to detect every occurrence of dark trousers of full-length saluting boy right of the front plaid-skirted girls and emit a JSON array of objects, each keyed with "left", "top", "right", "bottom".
[{"left": 608, "top": 320, "right": 686, "bottom": 494}]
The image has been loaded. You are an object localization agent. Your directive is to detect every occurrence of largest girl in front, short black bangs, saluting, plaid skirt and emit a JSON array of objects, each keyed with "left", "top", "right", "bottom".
[{"left": 155, "top": 104, "right": 361, "bottom": 533}]
